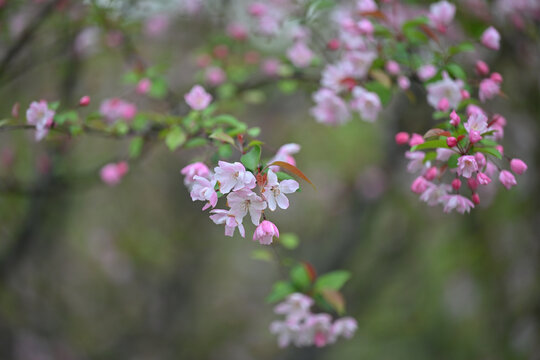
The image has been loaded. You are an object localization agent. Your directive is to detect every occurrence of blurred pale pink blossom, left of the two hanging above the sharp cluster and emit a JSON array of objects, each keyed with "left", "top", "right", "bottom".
[{"left": 311, "top": 89, "right": 351, "bottom": 125}]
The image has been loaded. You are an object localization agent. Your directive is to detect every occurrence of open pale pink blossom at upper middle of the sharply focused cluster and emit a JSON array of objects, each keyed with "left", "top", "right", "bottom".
[{"left": 214, "top": 161, "right": 256, "bottom": 194}]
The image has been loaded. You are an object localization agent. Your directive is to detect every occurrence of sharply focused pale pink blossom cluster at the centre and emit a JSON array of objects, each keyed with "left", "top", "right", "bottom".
[{"left": 181, "top": 144, "right": 299, "bottom": 245}]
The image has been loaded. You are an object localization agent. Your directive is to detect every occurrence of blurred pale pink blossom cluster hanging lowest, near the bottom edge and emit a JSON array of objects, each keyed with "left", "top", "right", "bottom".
[{"left": 270, "top": 293, "right": 358, "bottom": 347}]
